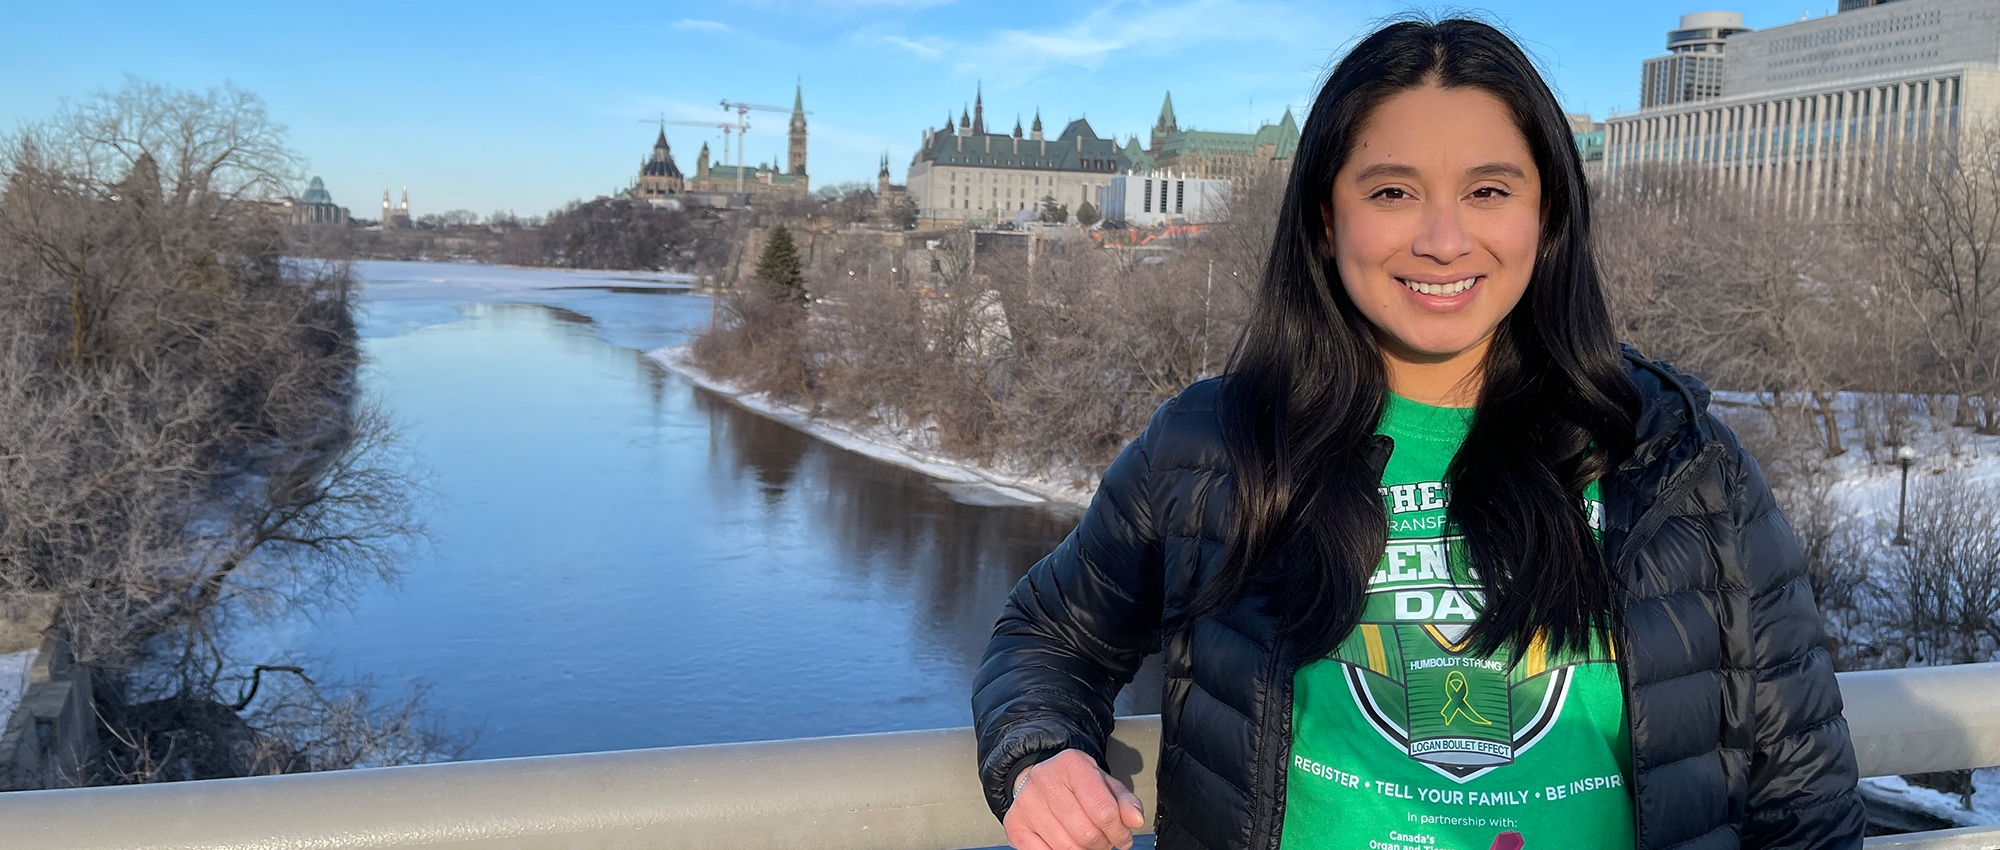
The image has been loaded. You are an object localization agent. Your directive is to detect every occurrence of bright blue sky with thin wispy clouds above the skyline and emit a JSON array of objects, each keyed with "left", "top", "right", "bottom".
[{"left": 0, "top": 0, "right": 1834, "bottom": 218}]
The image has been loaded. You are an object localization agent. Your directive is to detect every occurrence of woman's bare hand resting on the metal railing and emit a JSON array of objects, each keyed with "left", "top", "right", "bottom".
[{"left": 1002, "top": 750, "right": 1146, "bottom": 850}]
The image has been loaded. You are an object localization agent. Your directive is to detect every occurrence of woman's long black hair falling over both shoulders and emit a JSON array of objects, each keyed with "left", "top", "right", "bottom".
[{"left": 1190, "top": 20, "right": 1638, "bottom": 658}]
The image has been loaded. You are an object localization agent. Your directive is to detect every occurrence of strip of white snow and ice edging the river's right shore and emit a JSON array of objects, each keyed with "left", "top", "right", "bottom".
[{"left": 646, "top": 346, "right": 1098, "bottom": 510}]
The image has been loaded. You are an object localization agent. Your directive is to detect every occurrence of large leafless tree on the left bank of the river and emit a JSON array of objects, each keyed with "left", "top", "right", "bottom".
[{"left": 0, "top": 82, "right": 442, "bottom": 776}]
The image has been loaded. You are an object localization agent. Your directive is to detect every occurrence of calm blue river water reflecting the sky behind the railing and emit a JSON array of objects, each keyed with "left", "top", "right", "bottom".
[{"left": 288, "top": 262, "right": 1158, "bottom": 758}]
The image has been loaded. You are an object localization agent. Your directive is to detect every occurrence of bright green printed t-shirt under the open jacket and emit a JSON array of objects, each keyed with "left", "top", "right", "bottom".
[{"left": 1282, "top": 396, "right": 1634, "bottom": 850}]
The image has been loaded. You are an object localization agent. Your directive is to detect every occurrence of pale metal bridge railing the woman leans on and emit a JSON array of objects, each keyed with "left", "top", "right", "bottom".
[{"left": 0, "top": 664, "right": 2000, "bottom": 850}]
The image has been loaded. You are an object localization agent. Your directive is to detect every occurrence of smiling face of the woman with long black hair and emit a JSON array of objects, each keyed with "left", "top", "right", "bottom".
[{"left": 1326, "top": 86, "right": 1542, "bottom": 364}]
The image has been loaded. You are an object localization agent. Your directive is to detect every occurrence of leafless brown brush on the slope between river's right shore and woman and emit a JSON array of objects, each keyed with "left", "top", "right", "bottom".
[{"left": 694, "top": 170, "right": 1284, "bottom": 482}]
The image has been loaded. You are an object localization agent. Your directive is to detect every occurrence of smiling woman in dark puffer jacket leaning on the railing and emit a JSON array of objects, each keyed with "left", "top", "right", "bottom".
[{"left": 972, "top": 20, "right": 1862, "bottom": 850}]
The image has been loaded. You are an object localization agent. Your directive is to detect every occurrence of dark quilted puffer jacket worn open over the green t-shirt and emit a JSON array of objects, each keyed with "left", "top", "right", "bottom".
[{"left": 972, "top": 350, "right": 1862, "bottom": 850}]
